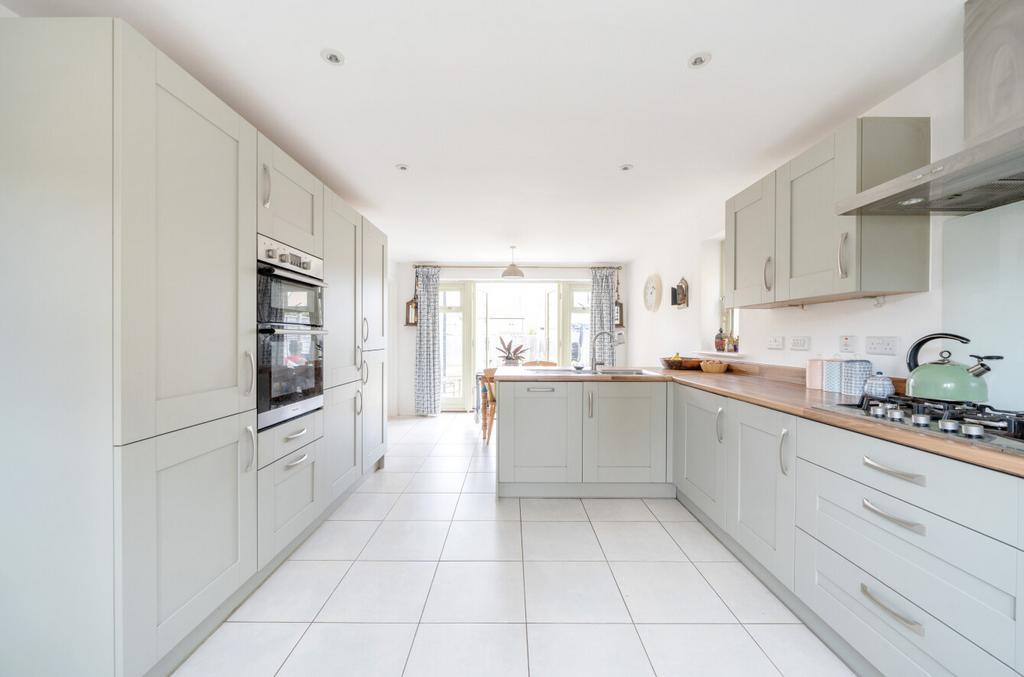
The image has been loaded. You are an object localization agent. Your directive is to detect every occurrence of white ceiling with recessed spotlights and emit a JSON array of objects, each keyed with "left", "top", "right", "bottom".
[{"left": 0, "top": 0, "right": 963, "bottom": 262}]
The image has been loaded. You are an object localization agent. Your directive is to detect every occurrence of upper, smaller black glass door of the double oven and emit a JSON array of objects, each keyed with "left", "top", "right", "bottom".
[{"left": 256, "top": 264, "right": 324, "bottom": 328}]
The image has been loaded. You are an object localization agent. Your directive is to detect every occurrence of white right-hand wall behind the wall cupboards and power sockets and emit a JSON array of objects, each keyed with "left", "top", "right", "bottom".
[{"left": 629, "top": 54, "right": 964, "bottom": 375}]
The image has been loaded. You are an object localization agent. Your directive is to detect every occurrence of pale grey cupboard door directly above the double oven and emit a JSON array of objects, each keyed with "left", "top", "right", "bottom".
[{"left": 257, "top": 134, "right": 324, "bottom": 257}]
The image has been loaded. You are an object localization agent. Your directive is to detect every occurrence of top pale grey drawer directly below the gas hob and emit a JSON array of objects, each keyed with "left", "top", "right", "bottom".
[{"left": 797, "top": 419, "right": 1020, "bottom": 545}]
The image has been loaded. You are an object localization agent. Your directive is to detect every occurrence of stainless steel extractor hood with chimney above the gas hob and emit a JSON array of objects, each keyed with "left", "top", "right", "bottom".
[{"left": 836, "top": 0, "right": 1024, "bottom": 215}]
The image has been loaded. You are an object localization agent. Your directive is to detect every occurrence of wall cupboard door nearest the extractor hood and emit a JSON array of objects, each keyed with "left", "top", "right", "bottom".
[{"left": 775, "top": 128, "right": 860, "bottom": 301}]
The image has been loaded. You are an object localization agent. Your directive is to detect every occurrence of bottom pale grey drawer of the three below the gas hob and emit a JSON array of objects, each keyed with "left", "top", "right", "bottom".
[{"left": 796, "top": 530, "right": 1014, "bottom": 677}]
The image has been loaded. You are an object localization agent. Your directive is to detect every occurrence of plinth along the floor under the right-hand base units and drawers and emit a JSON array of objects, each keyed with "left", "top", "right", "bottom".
[{"left": 676, "top": 491, "right": 885, "bottom": 677}]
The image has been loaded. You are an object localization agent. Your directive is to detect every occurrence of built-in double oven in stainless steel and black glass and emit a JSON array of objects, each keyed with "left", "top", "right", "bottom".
[{"left": 256, "top": 236, "right": 327, "bottom": 429}]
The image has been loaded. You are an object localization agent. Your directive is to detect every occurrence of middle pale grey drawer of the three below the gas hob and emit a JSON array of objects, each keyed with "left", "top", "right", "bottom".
[{"left": 797, "top": 460, "right": 1018, "bottom": 665}]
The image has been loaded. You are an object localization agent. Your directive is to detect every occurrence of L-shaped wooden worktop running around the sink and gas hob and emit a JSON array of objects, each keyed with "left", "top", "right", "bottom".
[{"left": 495, "top": 367, "right": 1024, "bottom": 477}]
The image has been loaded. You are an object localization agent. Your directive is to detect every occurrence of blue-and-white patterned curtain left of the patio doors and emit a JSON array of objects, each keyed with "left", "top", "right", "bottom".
[{"left": 416, "top": 266, "right": 441, "bottom": 416}]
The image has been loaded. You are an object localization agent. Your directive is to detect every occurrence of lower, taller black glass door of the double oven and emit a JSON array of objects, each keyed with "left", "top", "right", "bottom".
[{"left": 256, "top": 325, "right": 326, "bottom": 429}]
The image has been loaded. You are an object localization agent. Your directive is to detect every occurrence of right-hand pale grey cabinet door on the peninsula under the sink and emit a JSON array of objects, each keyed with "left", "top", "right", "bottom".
[{"left": 583, "top": 383, "right": 667, "bottom": 482}]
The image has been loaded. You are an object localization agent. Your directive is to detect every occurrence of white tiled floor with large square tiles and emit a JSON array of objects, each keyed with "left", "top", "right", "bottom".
[{"left": 177, "top": 414, "right": 851, "bottom": 677}]
